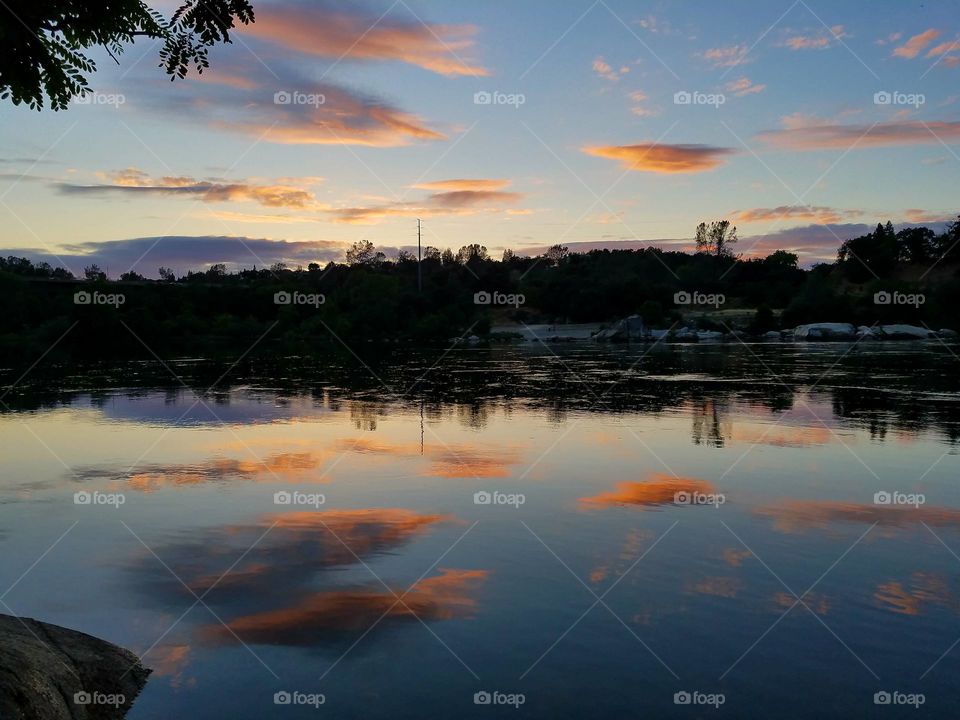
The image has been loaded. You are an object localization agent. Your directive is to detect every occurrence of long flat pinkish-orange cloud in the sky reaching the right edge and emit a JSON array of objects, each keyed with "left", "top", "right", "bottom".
[{"left": 758, "top": 121, "right": 960, "bottom": 150}]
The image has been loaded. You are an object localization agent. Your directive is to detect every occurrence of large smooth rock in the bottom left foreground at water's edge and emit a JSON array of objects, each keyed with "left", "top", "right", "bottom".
[{"left": 0, "top": 615, "right": 150, "bottom": 720}]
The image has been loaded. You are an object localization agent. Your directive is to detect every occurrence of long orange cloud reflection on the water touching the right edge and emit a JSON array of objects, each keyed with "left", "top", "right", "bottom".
[{"left": 754, "top": 500, "right": 960, "bottom": 533}]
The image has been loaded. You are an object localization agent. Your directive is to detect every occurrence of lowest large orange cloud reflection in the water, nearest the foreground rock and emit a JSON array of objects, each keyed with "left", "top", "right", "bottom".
[{"left": 200, "top": 569, "right": 488, "bottom": 646}]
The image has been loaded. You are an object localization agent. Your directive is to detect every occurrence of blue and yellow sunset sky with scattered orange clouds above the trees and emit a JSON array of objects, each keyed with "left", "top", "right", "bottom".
[{"left": 0, "top": 0, "right": 960, "bottom": 277}]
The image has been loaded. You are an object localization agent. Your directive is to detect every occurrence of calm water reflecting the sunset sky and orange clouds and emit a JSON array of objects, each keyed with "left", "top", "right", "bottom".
[{"left": 0, "top": 341, "right": 960, "bottom": 720}]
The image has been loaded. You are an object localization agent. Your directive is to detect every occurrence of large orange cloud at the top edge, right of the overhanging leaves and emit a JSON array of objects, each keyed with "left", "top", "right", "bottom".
[{"left": 244, "top": 2, "right": 490, "bottom": 77}]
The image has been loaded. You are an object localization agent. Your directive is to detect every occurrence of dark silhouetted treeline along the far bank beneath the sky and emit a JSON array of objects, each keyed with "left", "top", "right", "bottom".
[{"left": 0, "top": 221, "right": 960, "bottom": 357}]
